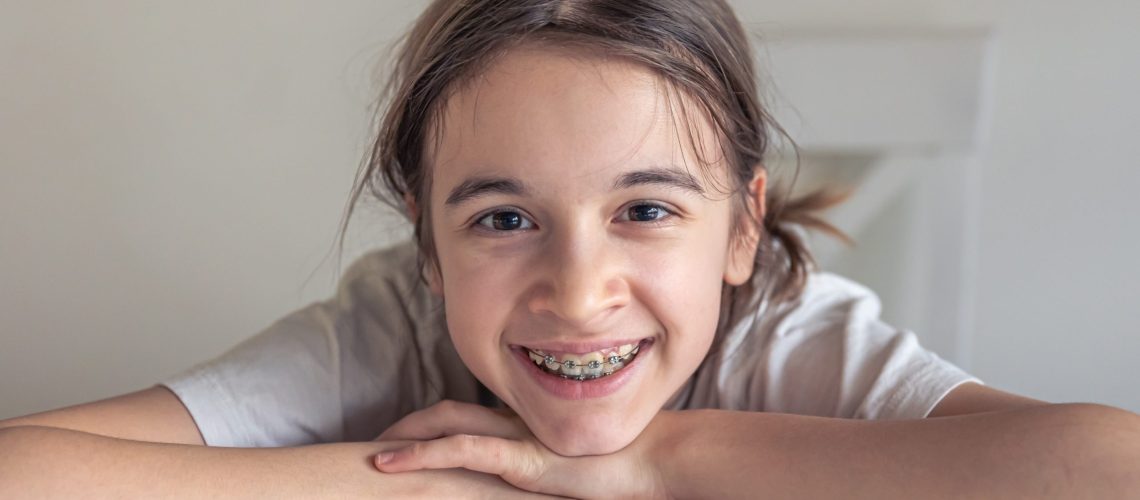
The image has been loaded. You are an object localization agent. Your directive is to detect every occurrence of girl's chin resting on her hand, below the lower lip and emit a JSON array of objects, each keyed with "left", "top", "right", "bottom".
[{"left": 530, "top": 410, "right": 645, "bottom": 457}]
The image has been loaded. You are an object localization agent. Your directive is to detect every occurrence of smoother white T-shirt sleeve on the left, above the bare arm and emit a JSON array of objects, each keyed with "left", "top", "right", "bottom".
[{"left": 162, "top": 302, "right": 343, "bottom": 448}]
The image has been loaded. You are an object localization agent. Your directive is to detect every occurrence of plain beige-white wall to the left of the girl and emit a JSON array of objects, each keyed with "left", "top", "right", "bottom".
[{"left": 0, "top": 0, "right": 420, "bottom": 418}]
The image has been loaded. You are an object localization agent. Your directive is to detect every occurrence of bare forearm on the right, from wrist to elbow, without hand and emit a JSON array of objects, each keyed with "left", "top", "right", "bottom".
[{"left": 660, "top": 405, "right": 1140, "bottom": 498}]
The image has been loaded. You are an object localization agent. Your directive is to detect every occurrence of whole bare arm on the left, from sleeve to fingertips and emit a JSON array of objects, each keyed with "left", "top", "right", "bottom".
[{"left": 0, "top": 386, "right": 554, "bottom": 498}]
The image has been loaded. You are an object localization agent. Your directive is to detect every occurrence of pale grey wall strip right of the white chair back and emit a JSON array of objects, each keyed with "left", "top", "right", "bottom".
[{"left": 972, "top": 0, "right": 1140, "bottom": 411}]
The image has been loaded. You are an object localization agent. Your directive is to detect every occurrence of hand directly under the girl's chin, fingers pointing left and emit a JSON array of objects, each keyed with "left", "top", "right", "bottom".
[{"left": 374, "top": 401, "right": 665, "bottom": 498}]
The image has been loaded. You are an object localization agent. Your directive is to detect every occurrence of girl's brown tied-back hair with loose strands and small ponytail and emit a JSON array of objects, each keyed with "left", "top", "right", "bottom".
[{"left": 330, "top": 0, "right": 849, "bottom": 332}]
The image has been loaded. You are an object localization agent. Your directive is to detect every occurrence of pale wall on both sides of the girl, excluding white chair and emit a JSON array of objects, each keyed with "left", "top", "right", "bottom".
[{"left": 0, "top": 0, "right": 1140, "bottom": 418}]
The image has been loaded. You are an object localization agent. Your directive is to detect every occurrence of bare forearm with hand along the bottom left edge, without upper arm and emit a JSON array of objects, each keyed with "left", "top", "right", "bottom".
[{"left": 0, "top": 427, "right": 540, "bottom": 498}]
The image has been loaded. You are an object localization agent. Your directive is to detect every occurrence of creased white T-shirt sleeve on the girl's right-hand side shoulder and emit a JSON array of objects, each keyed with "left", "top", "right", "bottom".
[{"left": 758, "top": 274, "right": 982, "bottom": 419}]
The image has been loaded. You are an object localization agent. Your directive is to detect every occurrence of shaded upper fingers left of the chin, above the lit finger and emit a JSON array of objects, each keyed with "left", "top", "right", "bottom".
[{"left": 375, "top": 400, "right": 528, "bottom": 441}]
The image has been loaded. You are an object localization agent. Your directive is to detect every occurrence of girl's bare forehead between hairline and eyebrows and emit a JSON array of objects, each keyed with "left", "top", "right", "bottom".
[{"left": 426, "top": 46, "right": 723, "bottom": 198}]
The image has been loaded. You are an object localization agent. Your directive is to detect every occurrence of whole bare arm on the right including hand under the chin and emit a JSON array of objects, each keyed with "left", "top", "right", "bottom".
[{"left": 376, "top": 384, "right": 1140, "bottom": 498}]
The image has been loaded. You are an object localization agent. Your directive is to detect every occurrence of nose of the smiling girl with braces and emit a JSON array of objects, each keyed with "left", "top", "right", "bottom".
[{"left": 529, "top": 226, "right": 629, "bottom": 330}]
